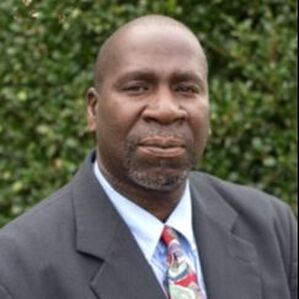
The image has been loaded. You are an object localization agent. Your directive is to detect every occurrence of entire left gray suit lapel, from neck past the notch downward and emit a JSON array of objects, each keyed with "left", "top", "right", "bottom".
[{"left": 73, "top": 157, "right": 165, "bottom": 299}]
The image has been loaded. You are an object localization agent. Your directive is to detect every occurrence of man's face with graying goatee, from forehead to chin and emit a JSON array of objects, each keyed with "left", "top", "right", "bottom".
[{"left": 89, "top": 28, "right": 209, "bottom": 191}]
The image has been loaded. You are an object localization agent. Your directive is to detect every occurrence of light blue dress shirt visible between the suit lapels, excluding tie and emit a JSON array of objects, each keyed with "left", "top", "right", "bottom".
[{"left": 94, "top": 162, "right": 206, "bottom": 294}]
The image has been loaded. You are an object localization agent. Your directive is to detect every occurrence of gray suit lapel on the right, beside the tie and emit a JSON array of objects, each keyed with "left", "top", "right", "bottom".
[{"left": 191, "top": 173, "right": 262, "bottom": 299}]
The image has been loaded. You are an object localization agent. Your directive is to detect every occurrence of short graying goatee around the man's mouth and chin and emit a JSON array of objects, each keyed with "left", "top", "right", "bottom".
[{"left": 124, "top": 133, "right": 198, "bottom": 192}]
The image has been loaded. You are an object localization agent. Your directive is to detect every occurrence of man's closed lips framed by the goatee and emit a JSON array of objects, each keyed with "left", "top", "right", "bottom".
[{"left": 138, "top": 136, "right": 185, "bottom": 158}]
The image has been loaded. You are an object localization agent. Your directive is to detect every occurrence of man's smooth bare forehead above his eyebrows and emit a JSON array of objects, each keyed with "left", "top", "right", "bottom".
[{"left": 105, "top": 26, "right": 207, "bottom": 84}]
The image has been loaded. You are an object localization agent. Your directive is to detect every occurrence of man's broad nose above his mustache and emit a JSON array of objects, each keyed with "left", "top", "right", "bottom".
[{"left": 143, "top": 88, "right": 187, "bottom": 125}]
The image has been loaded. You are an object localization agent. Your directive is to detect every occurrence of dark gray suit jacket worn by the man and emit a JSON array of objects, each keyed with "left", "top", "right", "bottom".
[{"left": 0, "top": 157, "right": 297, "bottom": 299}]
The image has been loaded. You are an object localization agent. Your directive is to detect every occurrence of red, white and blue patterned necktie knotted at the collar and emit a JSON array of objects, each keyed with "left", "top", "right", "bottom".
[{"left": 161, "top": 227, "right": 204, "bottom": 299}]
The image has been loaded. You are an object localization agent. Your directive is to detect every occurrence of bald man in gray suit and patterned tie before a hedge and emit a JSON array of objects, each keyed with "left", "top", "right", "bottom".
[{"left": 0, "top": 16, "right": 297, "bottom": 299}]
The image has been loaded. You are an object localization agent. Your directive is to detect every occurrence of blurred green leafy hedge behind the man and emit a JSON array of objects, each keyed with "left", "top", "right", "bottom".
[{"left": 0, "top": 0, "right": 297, "bottom": 227}]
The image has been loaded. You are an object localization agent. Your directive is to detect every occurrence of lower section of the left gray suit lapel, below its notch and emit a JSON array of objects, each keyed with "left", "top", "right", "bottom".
[{"left": 92, "top": 221, "right": 165, "bottom": 299}]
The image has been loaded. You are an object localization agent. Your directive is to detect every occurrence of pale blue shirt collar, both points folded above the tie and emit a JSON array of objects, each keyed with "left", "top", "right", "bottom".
[{"left": 94, "top": 161, "right": 196, "bottom": 260}]
